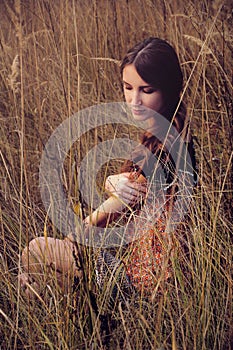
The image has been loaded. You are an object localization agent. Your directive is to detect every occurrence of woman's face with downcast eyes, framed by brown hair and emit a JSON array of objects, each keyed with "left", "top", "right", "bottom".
[{"left": 123, "top": 64, "right": 163, "bottom": 126}]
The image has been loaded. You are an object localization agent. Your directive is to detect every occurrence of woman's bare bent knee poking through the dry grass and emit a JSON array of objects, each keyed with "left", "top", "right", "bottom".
[{"left": 20, "top": 237, "right": 79, "bottom": 294}]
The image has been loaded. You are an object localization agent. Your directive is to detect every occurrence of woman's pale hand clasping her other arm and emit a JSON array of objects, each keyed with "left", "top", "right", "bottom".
[{"left": 105, "top": 172, "right": 147, "bottom": 204}]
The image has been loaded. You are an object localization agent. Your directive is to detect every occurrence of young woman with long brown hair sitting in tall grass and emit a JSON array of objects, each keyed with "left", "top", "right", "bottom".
[{"left": 21, "top": 38, "right": 195, "bottom": 295}]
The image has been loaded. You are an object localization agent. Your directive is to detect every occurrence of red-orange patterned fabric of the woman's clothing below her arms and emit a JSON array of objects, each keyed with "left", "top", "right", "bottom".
[{"left": 124, "top": 206, "right": 171, "bottom": 294}]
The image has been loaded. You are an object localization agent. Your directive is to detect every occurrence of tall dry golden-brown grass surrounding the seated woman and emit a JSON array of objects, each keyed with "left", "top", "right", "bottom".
[{"left": 0, "top": 0, "right": 233, "bottom": 350}]
